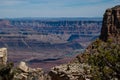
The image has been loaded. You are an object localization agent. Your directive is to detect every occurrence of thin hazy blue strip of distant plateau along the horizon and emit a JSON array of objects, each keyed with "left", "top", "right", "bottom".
[{"left": 0, "top": 17, "right": 103, "bottom": 21}]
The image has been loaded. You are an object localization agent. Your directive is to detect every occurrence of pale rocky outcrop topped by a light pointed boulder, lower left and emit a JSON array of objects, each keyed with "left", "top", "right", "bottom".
[{"left": 13, "top": 62, "right": 50, "bottom": 80}]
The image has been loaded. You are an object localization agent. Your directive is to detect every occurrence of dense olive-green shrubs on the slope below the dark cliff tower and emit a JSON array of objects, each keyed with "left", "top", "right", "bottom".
[{"left": 88, "top": 40, "right": 120, "bottom": 80}]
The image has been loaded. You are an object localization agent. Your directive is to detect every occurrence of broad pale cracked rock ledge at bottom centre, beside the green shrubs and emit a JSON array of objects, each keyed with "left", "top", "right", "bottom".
[{"left": 49, "top": 63, "right": 91, "bottom": 80}]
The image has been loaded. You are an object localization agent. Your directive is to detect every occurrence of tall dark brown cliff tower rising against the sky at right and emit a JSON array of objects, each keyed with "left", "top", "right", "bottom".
[{"left": 100, "top": 5, "right": 120, "bottom": 41}]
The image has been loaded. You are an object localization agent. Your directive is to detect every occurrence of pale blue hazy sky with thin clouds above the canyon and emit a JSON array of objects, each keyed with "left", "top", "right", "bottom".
[{"left": 0, "top": 0, "right": 120, "bottom": 18}]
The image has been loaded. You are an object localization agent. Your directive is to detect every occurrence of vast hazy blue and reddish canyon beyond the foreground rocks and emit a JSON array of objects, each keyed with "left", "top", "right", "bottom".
[{"left": 0, "top": 18, "right": 102, "bottom": 70}]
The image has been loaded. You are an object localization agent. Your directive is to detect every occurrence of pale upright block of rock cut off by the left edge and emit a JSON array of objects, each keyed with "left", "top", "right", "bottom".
[{"left": 0, "top": 48, "right": 7, "bottom": 65}]
